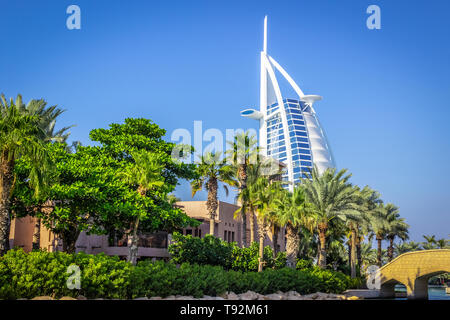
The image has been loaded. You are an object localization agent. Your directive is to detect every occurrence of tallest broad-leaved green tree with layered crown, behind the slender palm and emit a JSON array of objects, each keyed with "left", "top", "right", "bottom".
[{"left": 90, "top": 118, "right": 198, "bottom": 254}]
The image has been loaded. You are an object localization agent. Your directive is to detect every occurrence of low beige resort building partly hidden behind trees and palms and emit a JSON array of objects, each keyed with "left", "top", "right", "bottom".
[{"left": 9, "top": 201, "right": 286, "bottom": 259}]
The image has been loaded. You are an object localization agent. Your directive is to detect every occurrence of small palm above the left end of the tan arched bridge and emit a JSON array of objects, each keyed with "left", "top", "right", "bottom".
[{"left": 385, "top": 203, "right": 409, "bottom": 262}]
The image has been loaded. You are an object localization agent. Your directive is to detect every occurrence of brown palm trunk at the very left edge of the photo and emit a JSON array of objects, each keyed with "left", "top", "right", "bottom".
[{"left": 0, "top": 152, "right": 14, "bottom": 256}]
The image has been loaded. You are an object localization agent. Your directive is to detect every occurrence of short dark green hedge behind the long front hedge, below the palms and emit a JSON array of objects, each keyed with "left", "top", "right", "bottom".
[{"left": 169, "top": 233, "right": 286, "bottom": 271}]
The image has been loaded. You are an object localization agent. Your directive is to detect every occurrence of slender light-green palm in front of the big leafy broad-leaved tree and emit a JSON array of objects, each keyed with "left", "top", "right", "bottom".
[{"left": 120, "top": 150, "right": 164, "bottom": 265}]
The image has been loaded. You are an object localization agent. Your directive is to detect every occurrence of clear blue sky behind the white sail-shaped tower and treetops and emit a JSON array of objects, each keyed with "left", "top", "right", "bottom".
[{"left": 0, "top": 0, "right": 450, "bottom": 240}]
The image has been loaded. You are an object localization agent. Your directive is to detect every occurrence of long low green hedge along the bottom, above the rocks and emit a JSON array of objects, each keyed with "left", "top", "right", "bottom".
[{"left": 0, "top": 249, "right": 351, "bottom": 299}]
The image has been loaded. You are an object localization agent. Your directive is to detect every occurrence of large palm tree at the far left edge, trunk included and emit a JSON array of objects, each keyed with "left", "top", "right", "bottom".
[{"left": 0, "top": 94, "right": 67, "bottom": 255}]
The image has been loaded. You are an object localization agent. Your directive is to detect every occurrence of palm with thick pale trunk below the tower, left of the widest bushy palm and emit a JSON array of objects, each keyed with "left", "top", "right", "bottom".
[{"left": 275, "top": 185, "right": 311, "bottom": 268}]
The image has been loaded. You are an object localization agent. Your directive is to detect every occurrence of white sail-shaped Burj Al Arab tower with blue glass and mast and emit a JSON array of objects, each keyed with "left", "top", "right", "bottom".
[{"left": 241, "top": 16, "right": 335, "bottom": 190}]
